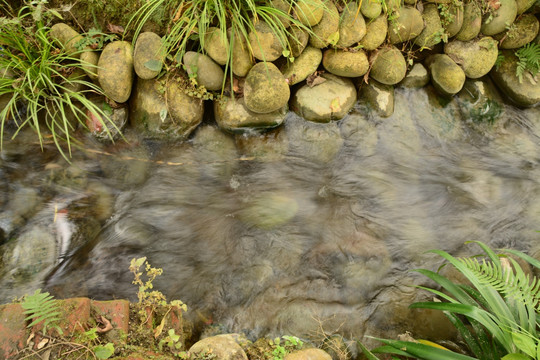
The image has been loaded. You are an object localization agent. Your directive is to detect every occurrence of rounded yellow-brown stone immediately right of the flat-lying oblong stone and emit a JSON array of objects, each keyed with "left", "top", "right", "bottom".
[{"left": 369, "top": 46, "right": 407, "bottom": 85}]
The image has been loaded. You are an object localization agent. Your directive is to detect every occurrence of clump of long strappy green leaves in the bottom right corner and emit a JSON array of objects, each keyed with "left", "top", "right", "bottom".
[{"left": 360, "top": 242, "right": 540, "bottom": 360}]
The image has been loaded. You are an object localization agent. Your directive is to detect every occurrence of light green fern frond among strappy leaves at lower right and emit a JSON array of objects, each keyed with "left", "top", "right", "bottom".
[{"left": 459, "top": 258, "right": 540, "bottom": 310}]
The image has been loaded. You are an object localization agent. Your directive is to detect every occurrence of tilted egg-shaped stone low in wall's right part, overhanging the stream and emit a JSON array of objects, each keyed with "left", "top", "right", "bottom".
[{"left": 426, "top": 54, "right": 466, "bottom": 96}]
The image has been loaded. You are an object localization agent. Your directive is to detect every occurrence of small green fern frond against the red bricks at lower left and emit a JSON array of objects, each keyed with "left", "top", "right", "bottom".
[{"left": 21, "top": 289, "right": 62, "bottom": 334}]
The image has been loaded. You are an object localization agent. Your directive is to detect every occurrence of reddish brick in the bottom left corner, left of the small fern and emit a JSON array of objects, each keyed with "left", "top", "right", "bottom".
[{"left": 0, "top": 304, "right": 27, "bottom": 359}]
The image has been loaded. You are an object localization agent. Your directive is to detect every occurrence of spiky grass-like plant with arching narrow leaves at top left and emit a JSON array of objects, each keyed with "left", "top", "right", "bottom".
[{"left": 0, "top": 0, "right": 114, "bottom": 159}]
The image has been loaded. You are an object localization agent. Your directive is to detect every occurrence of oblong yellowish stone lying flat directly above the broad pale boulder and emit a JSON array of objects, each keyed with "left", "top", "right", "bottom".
[{"left": 323, "top": 49, "right": 369, "bottom": 77}]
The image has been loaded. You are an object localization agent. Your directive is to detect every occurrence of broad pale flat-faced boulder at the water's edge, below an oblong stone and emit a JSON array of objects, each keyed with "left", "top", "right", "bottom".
[{"left": 291, "top": 74, "right": 357, "bottom": 122}]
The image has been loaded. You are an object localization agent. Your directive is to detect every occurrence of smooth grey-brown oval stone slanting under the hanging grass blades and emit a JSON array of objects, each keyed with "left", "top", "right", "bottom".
[{"left": 182, "top": 51, "right": 225, "bottom": 91}]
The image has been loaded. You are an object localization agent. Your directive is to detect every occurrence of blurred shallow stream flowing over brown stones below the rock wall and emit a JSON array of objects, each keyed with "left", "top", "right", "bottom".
[{"left": 0, "top": 81, "right": 540, "bottom": 346}]
